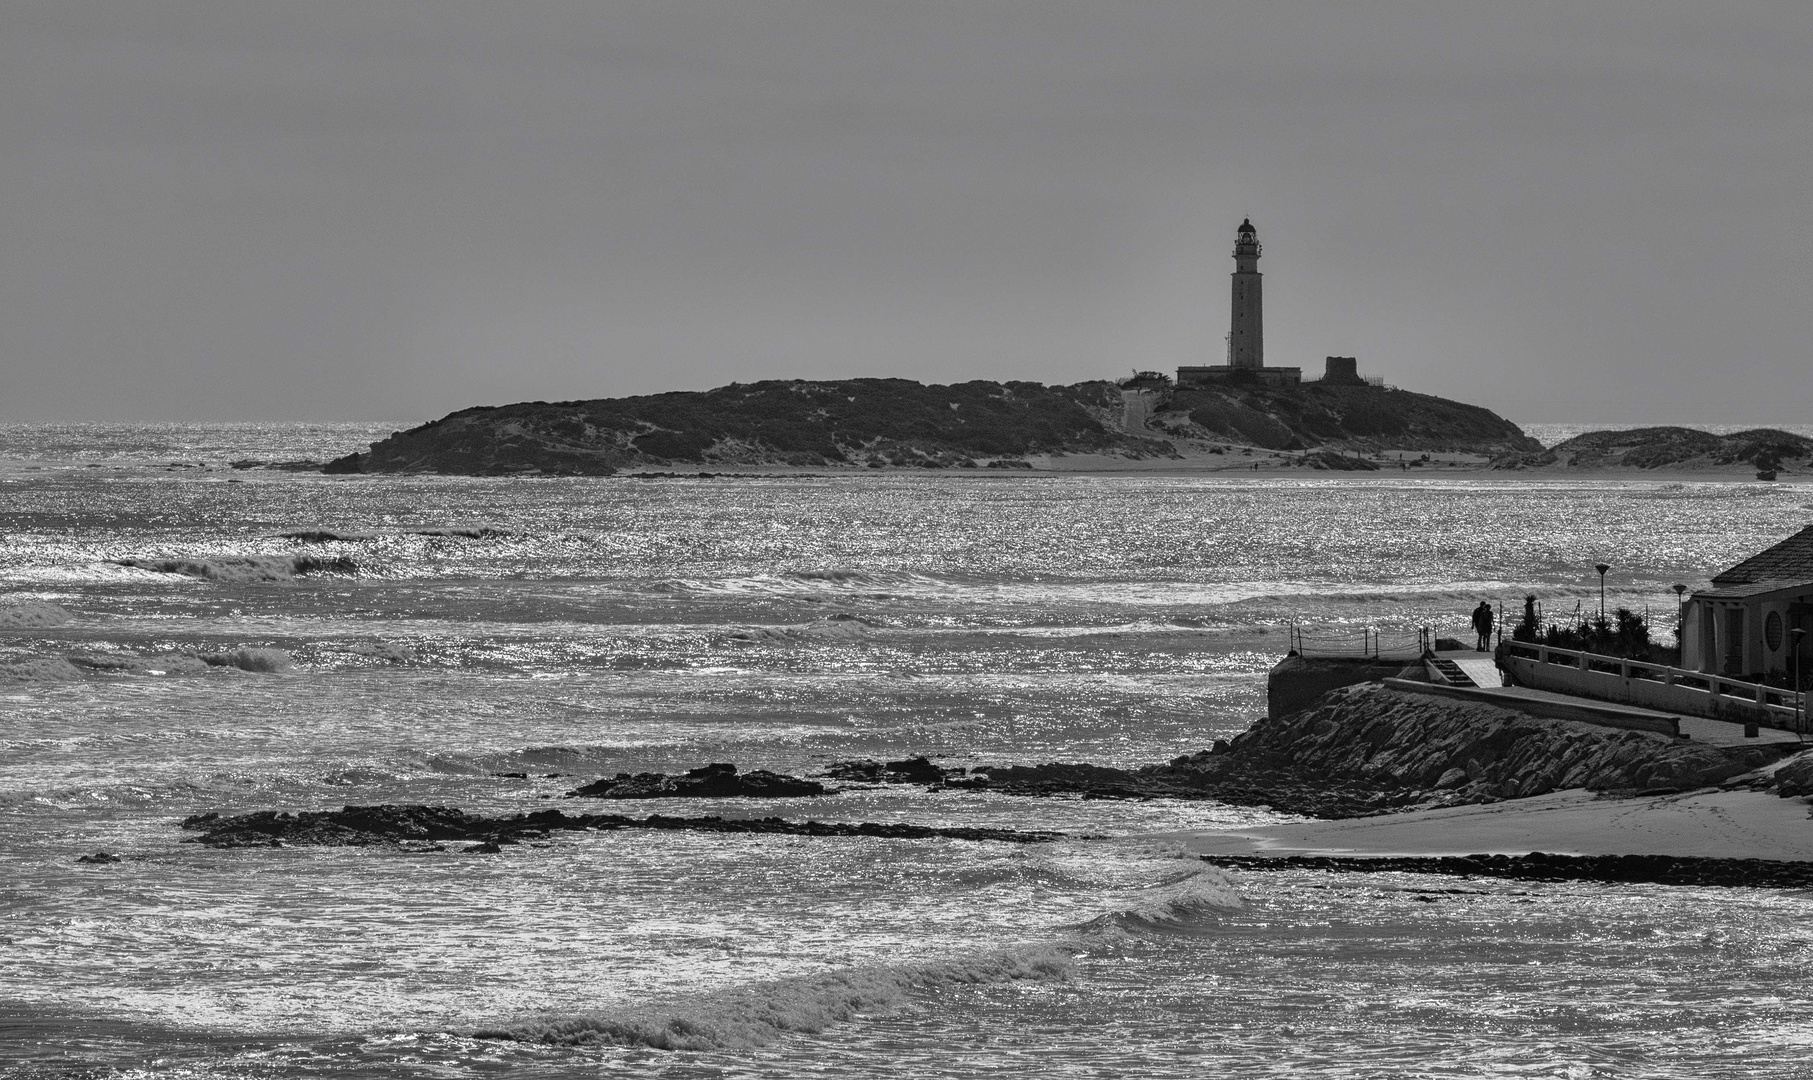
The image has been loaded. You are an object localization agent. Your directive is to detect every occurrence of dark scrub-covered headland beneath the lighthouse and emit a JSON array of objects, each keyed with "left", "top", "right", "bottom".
[{"left": 325, "top": 379, "right": 1541, "bottom": 477}]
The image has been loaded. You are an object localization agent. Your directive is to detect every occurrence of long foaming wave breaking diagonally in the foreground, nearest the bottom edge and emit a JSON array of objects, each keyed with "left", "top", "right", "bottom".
[{"left": 468, "top": 946, "right": 1075, "bottom": 1049}]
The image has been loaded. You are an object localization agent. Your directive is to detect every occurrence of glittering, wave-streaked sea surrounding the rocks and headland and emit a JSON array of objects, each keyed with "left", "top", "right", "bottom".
[{"left": 0, "top": 424, "right": 1813, "bottom": 1080}]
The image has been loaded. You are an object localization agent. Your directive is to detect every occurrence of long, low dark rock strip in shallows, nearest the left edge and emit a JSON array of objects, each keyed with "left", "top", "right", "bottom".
[{"left": 181, "top": 805, "right": 1064, "bottom": 855}]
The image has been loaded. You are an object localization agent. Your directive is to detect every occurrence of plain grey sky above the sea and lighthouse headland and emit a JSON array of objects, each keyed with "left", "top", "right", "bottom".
[{"left": 0, "top": 0, "right": 1813, "bottom": 422}]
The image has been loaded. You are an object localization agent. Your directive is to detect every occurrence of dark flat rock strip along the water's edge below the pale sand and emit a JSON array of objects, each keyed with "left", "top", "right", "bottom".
[{"left": 1202, "top": 852, "right": 1813, "bottom": 888}]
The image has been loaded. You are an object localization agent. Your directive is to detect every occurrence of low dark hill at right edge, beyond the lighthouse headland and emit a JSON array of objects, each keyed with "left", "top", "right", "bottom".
[{"left": 1492, "top": 428, "right": 1813, "bottom": 473}]
